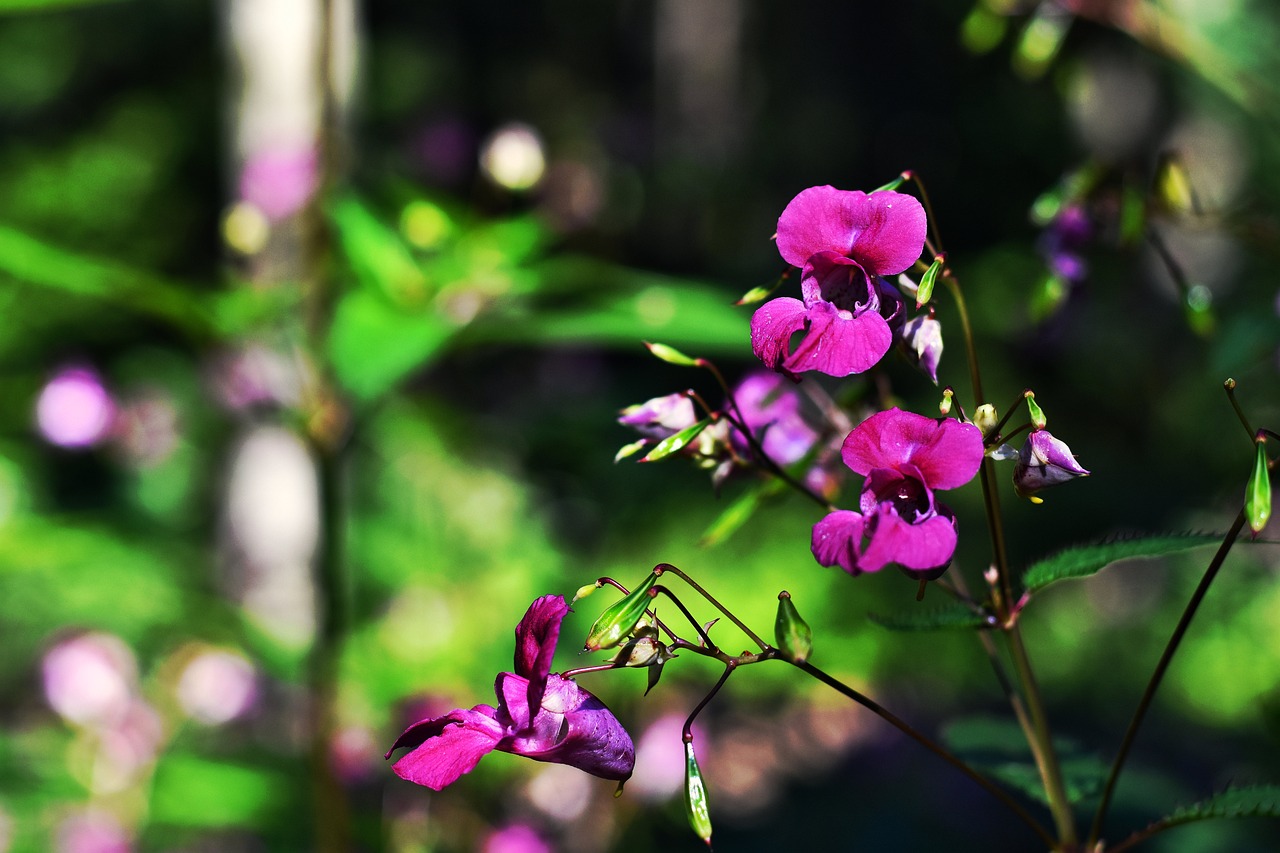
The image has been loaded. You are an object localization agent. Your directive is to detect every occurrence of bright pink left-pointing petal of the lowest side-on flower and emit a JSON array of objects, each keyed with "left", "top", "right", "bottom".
[{"left": 387, "top": 704, "right": 504, "bottom": 790}]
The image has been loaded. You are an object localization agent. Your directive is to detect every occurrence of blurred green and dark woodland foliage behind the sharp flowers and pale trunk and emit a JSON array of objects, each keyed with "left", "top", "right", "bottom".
[{"left": 0, "top": 0, "right": 1280, "bottom": 852}]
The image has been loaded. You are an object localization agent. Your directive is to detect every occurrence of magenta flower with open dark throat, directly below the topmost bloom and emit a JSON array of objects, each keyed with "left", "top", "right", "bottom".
[{"left": 812, "top": 409, "right": 983, "bottom": 580}]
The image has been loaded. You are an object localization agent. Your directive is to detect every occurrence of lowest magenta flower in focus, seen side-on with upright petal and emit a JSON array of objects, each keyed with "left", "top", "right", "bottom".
[{"left": 387, "top": 596, "right": 635, "bottom": 790}]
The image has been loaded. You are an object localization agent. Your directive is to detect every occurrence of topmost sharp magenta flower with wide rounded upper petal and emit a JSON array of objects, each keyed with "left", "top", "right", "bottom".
[{"left": 751, "top": 187, "right": 927, "bottom": 377}]
